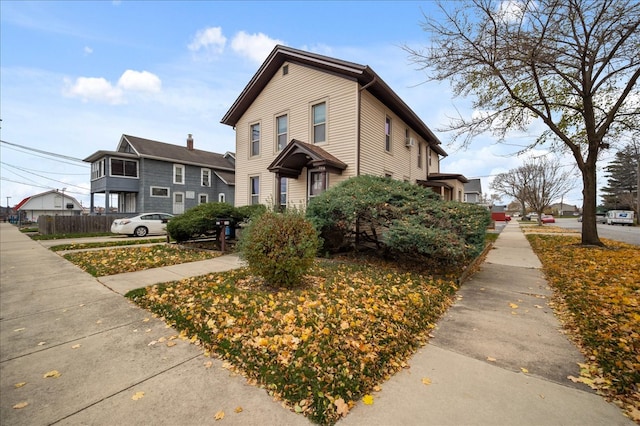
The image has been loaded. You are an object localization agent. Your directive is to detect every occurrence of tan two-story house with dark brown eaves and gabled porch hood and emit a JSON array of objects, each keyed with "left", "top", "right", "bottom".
[{"left": 221, "top": 45, "right": 466, "bottom": 207}]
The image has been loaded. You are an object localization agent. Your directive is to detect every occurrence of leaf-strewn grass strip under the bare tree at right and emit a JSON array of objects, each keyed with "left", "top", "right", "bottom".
[{"left": 527, "top": 235, "right": 640, "bottom": 423}]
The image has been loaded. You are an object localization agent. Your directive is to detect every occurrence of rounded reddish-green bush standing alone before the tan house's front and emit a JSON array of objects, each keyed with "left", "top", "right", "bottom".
[{"left": 238, "top": 211, "right": 319, "bottom": 288}]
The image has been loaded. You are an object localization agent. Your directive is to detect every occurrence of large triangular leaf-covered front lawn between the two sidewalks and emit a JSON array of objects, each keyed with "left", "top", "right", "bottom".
[{"left": 127, "top": 261, "right": 457, "bottom": 424}]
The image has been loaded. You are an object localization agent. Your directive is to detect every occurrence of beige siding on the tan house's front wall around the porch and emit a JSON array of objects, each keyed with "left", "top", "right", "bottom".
[{"left": 235, "top": 63, "right": 358, "bottom": 206}]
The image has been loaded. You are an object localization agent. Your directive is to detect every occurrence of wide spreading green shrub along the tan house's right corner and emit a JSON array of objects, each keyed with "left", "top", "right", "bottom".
[{"left": 307, "top": 176, "right": 490, "bottom": 265}]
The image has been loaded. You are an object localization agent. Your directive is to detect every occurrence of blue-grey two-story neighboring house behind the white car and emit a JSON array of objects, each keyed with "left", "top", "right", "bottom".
[{"left": 84, "top": 134, "right": 235, "bottom": 215}]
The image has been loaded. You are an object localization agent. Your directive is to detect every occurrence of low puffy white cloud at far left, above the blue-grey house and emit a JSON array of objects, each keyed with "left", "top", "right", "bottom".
[{"left": 64, "top": 70, "right": 162, "bottom": 105}]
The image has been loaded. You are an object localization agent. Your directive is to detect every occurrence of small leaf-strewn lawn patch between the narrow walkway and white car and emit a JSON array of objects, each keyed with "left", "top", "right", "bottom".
[{"left": 64, "top": 244, "right": 222, "bottom": 277}]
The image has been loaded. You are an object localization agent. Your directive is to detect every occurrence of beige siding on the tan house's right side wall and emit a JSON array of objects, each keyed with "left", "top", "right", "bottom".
[{"left": 360, "top": 91, "right": 438, "bottom": 183}]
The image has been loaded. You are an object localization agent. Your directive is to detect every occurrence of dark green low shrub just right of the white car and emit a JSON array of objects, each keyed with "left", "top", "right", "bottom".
[{"left": 167, "top": 203, "right": 236, "bottom": 242}]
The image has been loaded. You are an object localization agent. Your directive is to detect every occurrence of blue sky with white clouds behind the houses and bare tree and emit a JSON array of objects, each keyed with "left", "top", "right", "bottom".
[{"left": 0, "top": 0, "right": 606, "bottom": 210}]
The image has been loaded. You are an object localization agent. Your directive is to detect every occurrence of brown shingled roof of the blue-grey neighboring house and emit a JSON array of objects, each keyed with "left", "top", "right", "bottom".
[{"left": 83, "top": 134, "right": 235, "bottom": 172}]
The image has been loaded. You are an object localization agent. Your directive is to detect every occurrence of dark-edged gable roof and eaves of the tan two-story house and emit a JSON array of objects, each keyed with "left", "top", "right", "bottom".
[{"left": 220, "top": 45, "right": 447, "bottom": 156}]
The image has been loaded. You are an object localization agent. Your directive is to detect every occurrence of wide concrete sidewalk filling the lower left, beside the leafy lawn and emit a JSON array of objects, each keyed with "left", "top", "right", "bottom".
[{"left": 0, "top": 223, "right": 310, "bottom": 425}]
